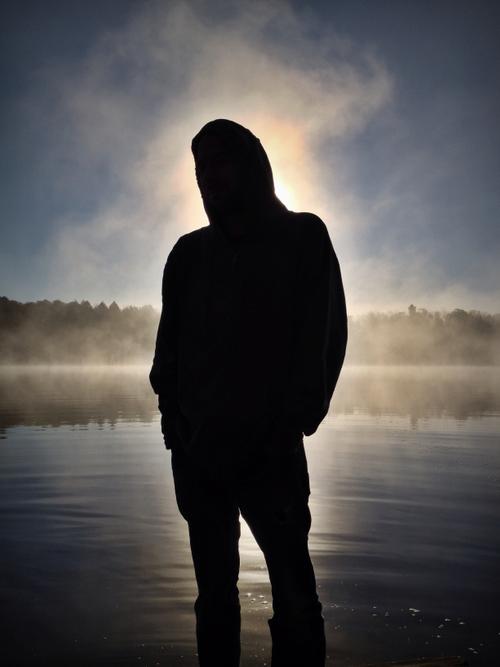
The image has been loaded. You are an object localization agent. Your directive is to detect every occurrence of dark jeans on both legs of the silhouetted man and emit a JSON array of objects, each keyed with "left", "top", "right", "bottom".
[{"left": 172, "top": 433, "right": 326, "bottom": 667}]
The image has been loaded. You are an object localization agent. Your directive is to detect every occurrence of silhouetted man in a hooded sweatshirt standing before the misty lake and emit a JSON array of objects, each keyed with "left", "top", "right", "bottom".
[{"left": 150, "top": 119, "right": 347, "bottom": 667}]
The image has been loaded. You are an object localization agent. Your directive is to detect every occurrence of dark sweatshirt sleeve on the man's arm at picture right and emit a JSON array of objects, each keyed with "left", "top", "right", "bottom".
[{"left": 285, "top": 214, "right": 347, "bottom": 435}]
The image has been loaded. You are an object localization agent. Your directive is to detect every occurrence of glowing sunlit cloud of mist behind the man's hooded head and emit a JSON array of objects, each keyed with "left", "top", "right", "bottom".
[{"left": 38, "top": 2, "right": 392, "bottom": 304}]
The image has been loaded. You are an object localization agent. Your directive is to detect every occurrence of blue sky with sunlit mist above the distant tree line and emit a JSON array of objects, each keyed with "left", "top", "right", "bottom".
[{"left": 0, "top": 0, "right": 500, "bottom": 314}]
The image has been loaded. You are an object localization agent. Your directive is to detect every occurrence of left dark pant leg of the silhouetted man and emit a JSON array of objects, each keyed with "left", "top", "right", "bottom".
[{"left": 172, "top": 449, "right": 241, "bottom": 667}]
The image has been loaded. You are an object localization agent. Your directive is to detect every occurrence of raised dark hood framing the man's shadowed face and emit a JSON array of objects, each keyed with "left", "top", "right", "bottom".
[{"left": 191, "top": 118, "right": 288, "bottom": 239}]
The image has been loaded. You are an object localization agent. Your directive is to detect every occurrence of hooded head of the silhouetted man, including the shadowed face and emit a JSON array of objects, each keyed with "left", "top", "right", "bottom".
[{"left": 191, "top": 118, "right": 283, "bottom": 235}]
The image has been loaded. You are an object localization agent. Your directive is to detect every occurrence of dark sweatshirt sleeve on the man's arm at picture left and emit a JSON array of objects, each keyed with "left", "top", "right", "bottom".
[{"left": 149, "top": 242, "right": 183, "bottom": 449}]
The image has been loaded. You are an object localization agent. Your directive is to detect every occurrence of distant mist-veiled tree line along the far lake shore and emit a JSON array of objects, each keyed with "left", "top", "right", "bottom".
[{"left": 0, "top": 297, "right": 500, "bottom": 365}]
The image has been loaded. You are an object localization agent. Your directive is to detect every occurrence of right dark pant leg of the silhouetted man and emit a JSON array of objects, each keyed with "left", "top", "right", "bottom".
[{"left": 238, "top": 436, "right": 326, "bottom": 667}]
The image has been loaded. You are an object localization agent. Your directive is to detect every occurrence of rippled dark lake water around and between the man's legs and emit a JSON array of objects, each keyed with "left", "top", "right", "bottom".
[{"left": 0, "top": 368, "right": 500, "bottom": 667}]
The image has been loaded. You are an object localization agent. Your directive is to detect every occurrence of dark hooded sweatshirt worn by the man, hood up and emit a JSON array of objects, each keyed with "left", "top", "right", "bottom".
[{"left": 150, "top": 119, "right": 347, "bottom": 474}]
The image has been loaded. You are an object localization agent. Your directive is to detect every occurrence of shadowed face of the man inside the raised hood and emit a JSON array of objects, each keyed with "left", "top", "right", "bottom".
[{"left": 195, "top": 135, "right": 245, "bottom": 212}]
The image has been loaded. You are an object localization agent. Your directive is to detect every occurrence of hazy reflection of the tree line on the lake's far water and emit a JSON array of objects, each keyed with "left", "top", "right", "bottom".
[{"left": 0, "top": 365, "right": 500, "bottom": 437}]
